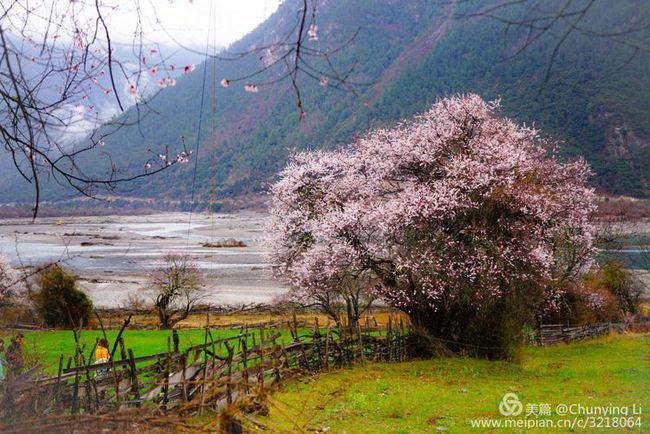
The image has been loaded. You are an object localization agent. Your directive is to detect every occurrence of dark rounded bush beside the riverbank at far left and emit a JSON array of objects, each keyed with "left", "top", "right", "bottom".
[{"left": 33, "top": 265, "right": 93, "bottom": 327}]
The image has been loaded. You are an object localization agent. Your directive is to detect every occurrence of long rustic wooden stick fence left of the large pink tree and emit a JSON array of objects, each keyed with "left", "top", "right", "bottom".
[{"left": 0, "top": 318, "right": 406, "bottom": 417}]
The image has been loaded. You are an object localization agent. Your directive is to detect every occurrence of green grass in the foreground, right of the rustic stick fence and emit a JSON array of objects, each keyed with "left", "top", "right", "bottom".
[{"left": 254, "top": 335, "right": 650, "bottom": 433}]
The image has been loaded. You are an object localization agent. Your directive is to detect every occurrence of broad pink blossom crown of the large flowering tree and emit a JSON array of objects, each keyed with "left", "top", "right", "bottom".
[{"left": 271, "top": 94, "right": 595, "bottom": 309}]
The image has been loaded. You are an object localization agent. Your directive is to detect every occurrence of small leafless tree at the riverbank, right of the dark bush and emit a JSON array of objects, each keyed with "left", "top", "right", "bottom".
[{"left": 150, "top": 253, "right": 204, "bottom": 329}]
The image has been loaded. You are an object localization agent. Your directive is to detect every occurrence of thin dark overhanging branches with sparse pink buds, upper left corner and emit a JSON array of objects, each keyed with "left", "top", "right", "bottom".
[{"left": 0, "top": 0, "right": 181, "bottom": 217}]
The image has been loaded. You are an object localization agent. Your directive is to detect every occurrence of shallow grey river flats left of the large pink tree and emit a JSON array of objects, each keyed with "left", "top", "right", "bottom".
[{"left": 0, "top": 212, "right": 284, "bottom": 307}]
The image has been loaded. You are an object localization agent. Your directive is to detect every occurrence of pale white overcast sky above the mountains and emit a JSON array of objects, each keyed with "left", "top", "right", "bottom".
[{"left": 7, "top": 0, "right": 280, "bottom": 51}]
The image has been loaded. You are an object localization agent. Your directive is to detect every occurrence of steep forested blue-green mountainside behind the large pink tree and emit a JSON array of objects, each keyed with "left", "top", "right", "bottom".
[{"left": 0, "top": 0, "right": 650, "bottom": 205}]
